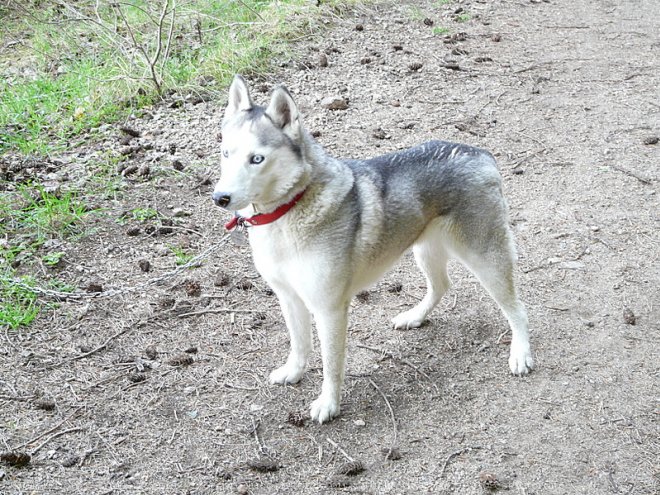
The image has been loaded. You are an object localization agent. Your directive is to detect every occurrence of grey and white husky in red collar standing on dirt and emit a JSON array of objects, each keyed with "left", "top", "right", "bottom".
[{"left": 212, "top": 75, "right": 533, "bottom": 423}]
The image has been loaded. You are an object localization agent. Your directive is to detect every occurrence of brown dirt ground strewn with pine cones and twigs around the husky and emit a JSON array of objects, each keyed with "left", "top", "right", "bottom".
[{"left": 0, "top": 0, "right": 660, "bottom": 495}]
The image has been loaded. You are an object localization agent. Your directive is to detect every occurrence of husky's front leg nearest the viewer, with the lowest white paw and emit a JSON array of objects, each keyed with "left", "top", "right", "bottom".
[{"left": 310, "top": 304, "right": 348, "bottom": 423}]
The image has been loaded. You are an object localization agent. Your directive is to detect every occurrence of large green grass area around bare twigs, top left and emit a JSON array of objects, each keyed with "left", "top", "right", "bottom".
[{"left": 0, "top": 0, "right": 354, "bottom": 155}]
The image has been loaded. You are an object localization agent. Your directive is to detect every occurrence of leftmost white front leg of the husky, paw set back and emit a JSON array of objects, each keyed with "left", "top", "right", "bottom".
[{"left": 269, "top": 287, "right": 312, "bottom": 384}]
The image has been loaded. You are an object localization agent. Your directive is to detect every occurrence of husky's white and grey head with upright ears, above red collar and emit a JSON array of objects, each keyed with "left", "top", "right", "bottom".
[{"left": 213, "top": 75, "right": 310, "bottom": 210}]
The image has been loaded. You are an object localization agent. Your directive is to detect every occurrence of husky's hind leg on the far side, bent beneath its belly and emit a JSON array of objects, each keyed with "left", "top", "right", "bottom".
[{"left": 392, "top": 223, "right": 450, "bottom": 330}]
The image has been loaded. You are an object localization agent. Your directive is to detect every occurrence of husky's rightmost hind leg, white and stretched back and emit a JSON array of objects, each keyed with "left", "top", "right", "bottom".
[{"left": 455, "top": 230, "right": 534, "bottom": 375}]
